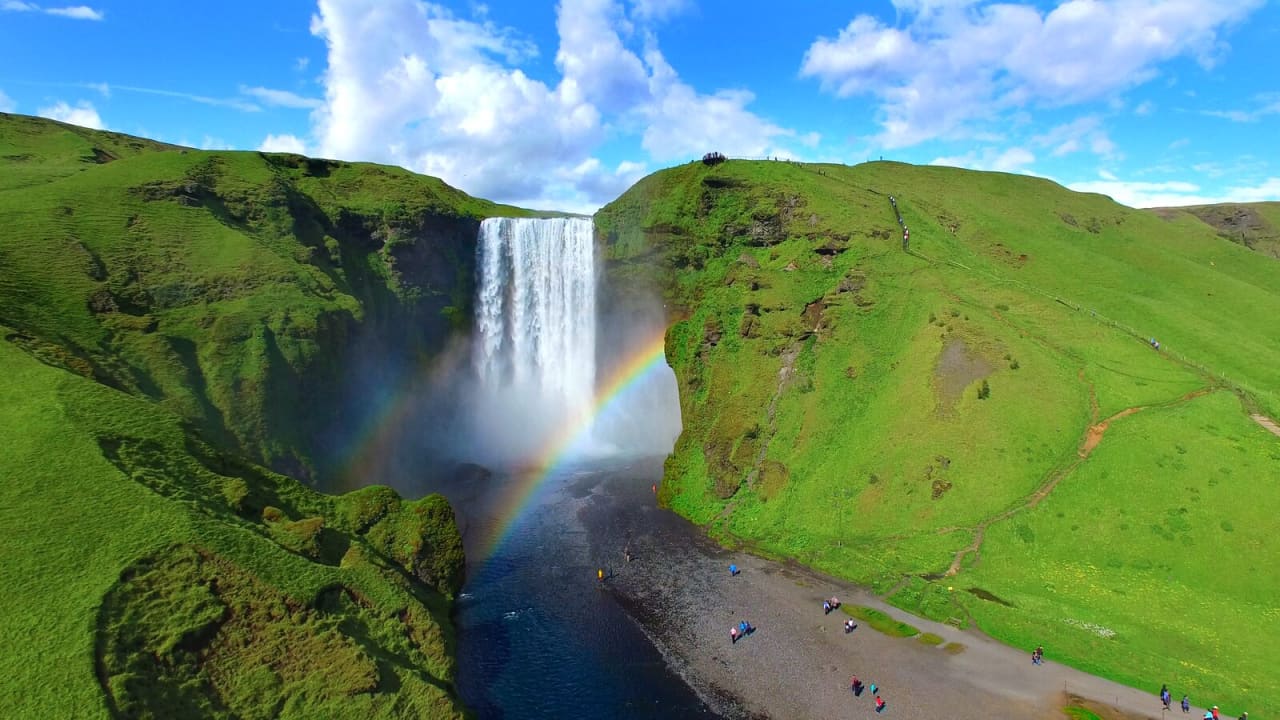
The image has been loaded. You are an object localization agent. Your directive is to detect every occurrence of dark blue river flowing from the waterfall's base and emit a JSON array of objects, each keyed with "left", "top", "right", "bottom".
[{"left": 444, "top": 459, "right": 721, "bottom": 719}]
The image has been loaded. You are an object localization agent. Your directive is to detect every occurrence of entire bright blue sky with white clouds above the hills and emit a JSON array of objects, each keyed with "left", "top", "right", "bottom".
[{"left": 0, "top": 0, "right": 1280, "bottom": 210}]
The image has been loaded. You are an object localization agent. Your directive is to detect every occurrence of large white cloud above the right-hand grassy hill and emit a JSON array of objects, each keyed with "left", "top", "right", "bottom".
[{"left": 800, "top": 0, "right": 1263, "bottom": 147}]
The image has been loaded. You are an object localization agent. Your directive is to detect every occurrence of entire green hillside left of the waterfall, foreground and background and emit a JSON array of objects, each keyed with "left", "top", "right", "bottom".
[{"left": 0, "top": 114, "right": 524, "bottom": 717}]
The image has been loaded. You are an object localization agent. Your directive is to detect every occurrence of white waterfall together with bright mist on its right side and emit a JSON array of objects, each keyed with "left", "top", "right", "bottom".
[{"left": 468, "top": 212, "right": 680, "bottom": 464}]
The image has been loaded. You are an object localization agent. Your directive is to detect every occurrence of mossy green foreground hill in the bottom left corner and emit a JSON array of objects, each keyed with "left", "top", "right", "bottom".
[{"left": 0, "top": 342, "right": 471, "bottom": 717}]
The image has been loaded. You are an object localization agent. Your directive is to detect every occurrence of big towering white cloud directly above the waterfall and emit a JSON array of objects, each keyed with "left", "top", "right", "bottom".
[{"left": 298, "top": 0, "right": 801, "bottom": 211}]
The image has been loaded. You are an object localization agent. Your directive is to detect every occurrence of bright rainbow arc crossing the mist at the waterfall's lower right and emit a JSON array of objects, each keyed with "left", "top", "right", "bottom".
[{"left": 486, "top": 332, "right": 667, "bottom": 555}]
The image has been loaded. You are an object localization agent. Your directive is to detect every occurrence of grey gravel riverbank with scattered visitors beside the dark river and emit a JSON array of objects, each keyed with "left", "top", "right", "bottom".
[{"left": 580, "top": 461, "right": 1203, "bottom": 720}]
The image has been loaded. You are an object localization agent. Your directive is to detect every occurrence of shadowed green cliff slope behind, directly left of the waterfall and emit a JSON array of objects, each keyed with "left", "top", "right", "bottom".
[{"left": 0, "top": 110, "right": 524, "bottom": 477}]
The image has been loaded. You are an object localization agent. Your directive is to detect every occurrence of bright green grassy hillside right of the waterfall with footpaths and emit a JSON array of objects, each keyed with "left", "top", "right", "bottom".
[{"left": 596, "top": 161, "right": 1280, "bottom": 707}]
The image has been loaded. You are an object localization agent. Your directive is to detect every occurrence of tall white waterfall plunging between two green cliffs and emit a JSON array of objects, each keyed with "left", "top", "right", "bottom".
[{"left": 472, "top": 218, "right": 596, "bottom": 456}]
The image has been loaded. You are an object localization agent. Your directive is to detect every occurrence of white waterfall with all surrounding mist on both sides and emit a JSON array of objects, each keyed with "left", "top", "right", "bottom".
[{"left": 340, "top": 212, "right": 681, "bottom": 489}]
